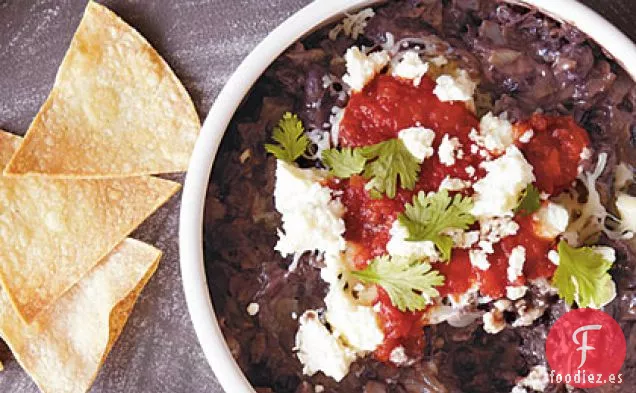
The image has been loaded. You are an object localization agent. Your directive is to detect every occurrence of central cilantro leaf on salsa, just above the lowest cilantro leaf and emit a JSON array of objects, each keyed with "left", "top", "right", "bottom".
[{"left": 398, "top": 190, "right": 475, "bottom": 261}]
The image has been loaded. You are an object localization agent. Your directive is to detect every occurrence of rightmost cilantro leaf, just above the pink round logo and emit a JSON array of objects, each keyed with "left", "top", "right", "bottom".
[{"left": 552, "top": 240, "right": 616, "bottom": 308}]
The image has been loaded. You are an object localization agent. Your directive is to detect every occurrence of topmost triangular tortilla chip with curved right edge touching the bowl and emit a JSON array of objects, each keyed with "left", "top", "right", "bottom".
[{"left": 6, "top": 2, "right": 200, "bottom": 178}]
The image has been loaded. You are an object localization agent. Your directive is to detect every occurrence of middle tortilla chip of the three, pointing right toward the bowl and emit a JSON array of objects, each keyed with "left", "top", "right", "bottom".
[{"left": 0, "top": 177, "right": 180, "bottom": 322}]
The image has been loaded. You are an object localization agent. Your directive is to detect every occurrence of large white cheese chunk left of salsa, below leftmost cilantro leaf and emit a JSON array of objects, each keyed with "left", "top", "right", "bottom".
[{"left": 274, "top": 160, "right": 346, "bottom": 256}]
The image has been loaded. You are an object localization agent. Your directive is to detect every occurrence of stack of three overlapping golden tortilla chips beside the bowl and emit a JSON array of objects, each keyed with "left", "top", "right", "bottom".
[{"left": 0, "top": 2, "right": 200, "bottom": 393}]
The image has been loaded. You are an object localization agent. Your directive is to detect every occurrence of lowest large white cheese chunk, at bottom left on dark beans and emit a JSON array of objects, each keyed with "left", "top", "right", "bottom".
[{"left": 295, "top": 310, "right": 356, "bottom": 381}]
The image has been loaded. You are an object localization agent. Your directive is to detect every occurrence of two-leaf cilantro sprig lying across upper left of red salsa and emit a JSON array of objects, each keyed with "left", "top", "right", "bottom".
[{"left": 322, "top": 138, "right": 420, "bottom": 199}]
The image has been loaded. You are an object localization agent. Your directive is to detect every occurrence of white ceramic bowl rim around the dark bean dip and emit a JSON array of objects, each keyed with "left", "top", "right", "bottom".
[{"left": 179, "top": 0, "right": 636, "bottom": 393}]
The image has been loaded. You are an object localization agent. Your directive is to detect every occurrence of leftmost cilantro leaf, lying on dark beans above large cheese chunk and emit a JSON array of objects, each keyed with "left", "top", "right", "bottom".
[{"left": 265, "top": 112, "right": 309, "bottom": 163}]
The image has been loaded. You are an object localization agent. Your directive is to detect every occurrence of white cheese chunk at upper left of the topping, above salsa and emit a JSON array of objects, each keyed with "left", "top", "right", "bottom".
[{"left": 342, "top": 46, "right": 391, "bottom": 92}]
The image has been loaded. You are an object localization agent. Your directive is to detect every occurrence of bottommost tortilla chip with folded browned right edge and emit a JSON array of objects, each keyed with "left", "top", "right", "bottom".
[{"left": 0, "top": 239, "right": 161, "bottom": 393}]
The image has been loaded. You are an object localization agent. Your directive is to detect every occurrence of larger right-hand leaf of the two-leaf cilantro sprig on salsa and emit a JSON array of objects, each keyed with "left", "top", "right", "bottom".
[{"left": 361, "top": 139, "right": 420, "bottom": 199}]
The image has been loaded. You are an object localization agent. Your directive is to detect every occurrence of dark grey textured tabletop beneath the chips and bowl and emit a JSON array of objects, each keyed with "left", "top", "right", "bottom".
[{"left": 0, "top": 0, "right": 636, "bottom": 393}]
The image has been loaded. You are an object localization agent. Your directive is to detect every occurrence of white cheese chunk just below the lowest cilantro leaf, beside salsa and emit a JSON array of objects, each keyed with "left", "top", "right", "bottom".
[{"left": 325, "top": 285, "right": 384, "bottom": 352}]
